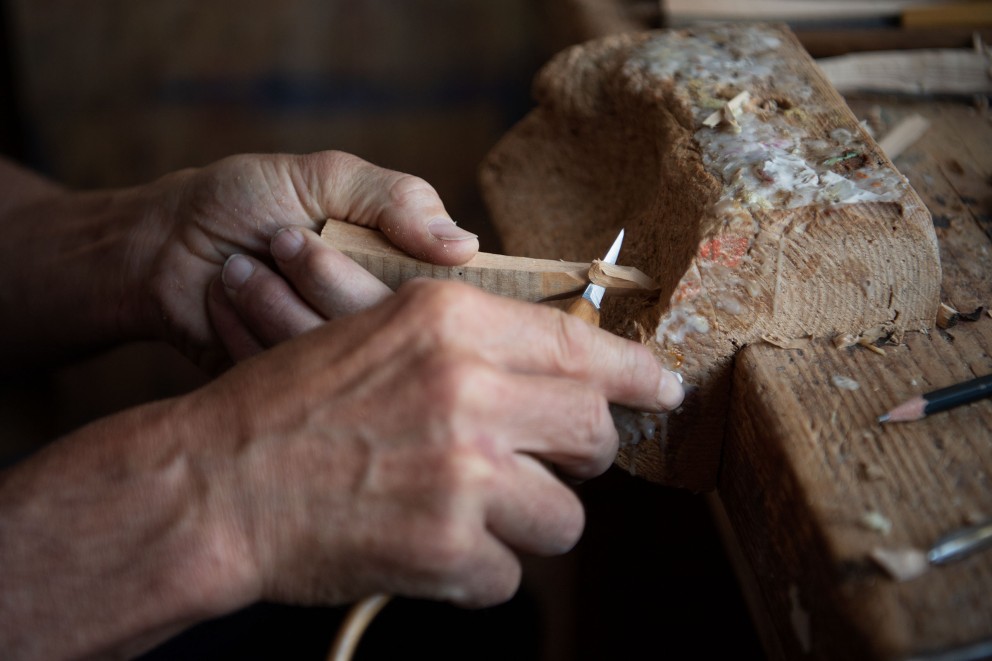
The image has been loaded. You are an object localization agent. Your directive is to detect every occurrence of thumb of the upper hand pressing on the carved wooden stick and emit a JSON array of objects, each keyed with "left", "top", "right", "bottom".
[{"left": 299, "top": 152, "right": 479, "bottom": 266}]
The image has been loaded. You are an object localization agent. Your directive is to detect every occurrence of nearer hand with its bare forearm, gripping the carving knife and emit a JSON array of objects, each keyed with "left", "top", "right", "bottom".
[{"left": 0, "top": 281, "right": 682, "bottom": 658}]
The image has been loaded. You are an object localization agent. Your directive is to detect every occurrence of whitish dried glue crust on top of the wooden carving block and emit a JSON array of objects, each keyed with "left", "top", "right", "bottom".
[{"left": 627, "top": 26, "right": 905, "bottom": 210}]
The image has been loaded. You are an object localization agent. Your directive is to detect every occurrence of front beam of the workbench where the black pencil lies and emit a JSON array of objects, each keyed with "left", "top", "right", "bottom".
[{"left": 719, "top": 332, "right": 992, "bottom": 660}]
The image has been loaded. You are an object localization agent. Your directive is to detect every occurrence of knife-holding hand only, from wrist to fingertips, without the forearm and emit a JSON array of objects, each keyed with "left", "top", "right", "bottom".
[{"left": 195, "top": 281, "right": 682, "bottom": 606}]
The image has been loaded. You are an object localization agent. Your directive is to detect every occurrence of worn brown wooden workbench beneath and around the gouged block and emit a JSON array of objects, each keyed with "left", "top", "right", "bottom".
[{"left": 551, "top": 0, "right": 992, "bottom": 660}]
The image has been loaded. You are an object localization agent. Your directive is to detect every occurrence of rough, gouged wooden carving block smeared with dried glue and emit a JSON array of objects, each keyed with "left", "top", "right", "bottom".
[{"left": 481, "top": 26, "right": 940, "bottom": 490}]
